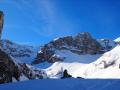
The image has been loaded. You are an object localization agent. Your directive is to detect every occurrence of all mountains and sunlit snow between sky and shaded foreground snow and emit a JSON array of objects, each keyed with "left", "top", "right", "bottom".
[{"left": 0, "top": 32, "right": 120, "bottom": 83}]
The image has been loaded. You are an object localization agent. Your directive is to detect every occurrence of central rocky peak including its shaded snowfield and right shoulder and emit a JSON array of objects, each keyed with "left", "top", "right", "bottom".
[{"left": 32, "top": 32, "right": 116, "bottom": 64}]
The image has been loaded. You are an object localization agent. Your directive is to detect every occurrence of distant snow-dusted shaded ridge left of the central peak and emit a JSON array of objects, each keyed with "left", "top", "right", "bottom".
[{"left": 0, "top": 40, "right": 38, "bottom": 64}]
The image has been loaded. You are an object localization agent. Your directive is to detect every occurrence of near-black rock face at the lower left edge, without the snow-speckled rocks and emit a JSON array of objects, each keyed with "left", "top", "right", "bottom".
[{"left": 0, "top": 49, "right": 20, "bottom": 83}]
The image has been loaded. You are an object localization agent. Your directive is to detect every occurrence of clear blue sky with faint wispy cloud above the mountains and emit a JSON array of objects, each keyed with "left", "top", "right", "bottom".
[{"left": 0, "top": 0, "right": 120, "bottom": 45}]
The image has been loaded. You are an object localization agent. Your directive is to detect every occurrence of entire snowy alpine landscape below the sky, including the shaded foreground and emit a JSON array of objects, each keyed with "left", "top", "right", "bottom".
[{"left": 0, "top": 11, "right": 120, "bottom": 90}]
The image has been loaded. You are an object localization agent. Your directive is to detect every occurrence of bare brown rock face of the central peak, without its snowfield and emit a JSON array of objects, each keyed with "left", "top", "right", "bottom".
[{"left": 32, "top": 32, "right": 102, "bottom": 64}]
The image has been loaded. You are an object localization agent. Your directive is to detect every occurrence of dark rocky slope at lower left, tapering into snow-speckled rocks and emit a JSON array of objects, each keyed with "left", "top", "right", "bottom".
[{"left": 0, "top": 49, "right": 46, "bottom": 84}]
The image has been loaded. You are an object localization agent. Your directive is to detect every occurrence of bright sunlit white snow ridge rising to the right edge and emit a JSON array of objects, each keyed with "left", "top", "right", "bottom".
[{"left": 46, "top": 45, "right": 120, "bottom": 79}]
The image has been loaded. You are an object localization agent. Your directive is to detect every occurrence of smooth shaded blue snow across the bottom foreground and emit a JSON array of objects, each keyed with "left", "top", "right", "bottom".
[{"left": 0, "top": 78, "right": 120, "bottom": 90}]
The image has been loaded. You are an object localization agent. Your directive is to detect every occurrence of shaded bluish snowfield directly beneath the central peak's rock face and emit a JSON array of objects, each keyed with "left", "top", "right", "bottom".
[{"left": 55, "top": 50, "right": 101, "bottom": 63}]
